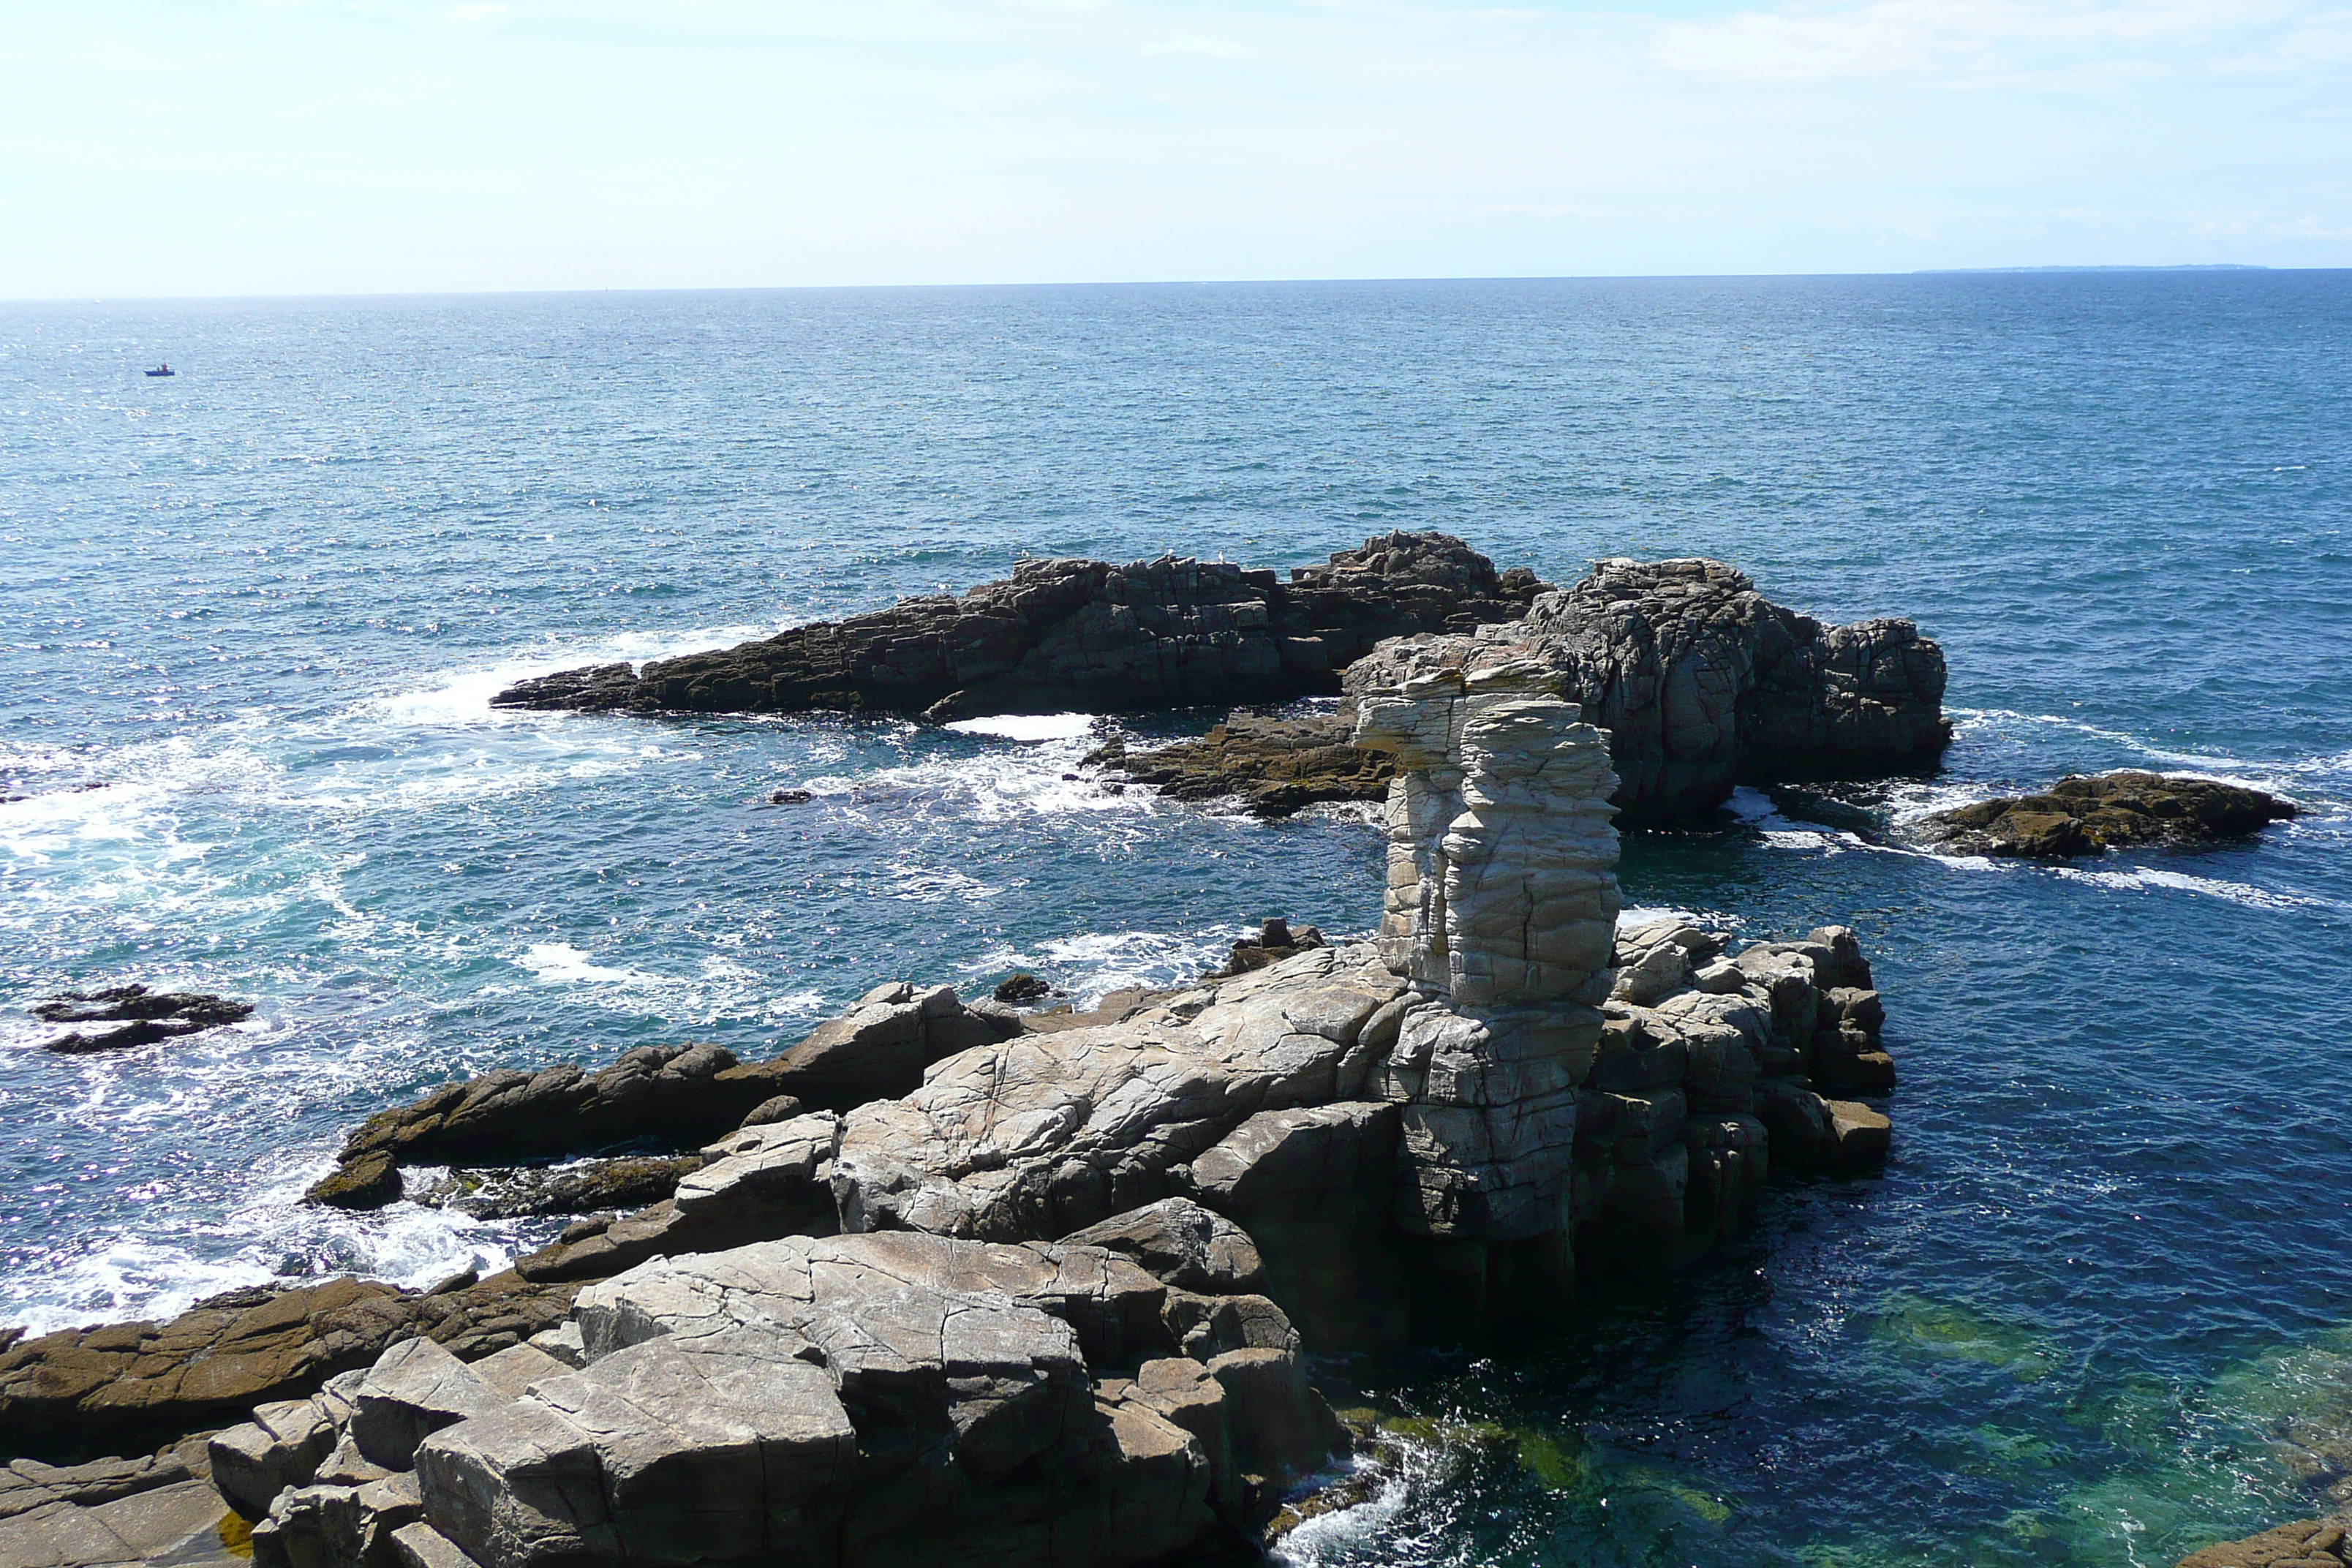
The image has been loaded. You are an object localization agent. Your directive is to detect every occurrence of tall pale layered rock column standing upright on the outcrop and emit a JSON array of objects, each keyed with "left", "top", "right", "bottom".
[{"left": 1354, "top": 660, "right": 1623, "bottom": 1264}]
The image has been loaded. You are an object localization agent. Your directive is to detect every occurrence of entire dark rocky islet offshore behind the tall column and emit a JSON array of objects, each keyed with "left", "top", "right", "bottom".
[{"left": 482, "top": 534, "right": 1952, "bottom": 825}]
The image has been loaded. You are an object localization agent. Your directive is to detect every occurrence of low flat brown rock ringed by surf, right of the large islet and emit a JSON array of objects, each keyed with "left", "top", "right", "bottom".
[{"left": 1919, "top": 774, "right": 2296, "bottom": 860}]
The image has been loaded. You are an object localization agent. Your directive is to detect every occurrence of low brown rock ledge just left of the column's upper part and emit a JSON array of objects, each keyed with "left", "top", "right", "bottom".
[{"left": 1087, "top": 710, "right": 1397, "bottom": 818}]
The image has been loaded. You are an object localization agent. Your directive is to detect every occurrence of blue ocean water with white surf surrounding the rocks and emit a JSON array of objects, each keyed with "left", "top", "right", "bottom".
[{"left": 0, "top": 273, "right": 2352, "bottom": 1568}]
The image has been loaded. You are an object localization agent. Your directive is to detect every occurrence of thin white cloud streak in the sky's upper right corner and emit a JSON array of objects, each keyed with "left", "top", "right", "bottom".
[{"left": 1654, "top": 0, "right": 2338, "bottom": 85}]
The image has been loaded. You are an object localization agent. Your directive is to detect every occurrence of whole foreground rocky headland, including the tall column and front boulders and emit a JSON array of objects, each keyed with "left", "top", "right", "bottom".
[{"left": 0, "top": 660, "right": 1893, "bottom": 1568}]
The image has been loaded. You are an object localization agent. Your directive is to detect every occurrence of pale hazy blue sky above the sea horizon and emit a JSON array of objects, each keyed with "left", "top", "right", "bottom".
[{"left": 0, "top": 0, "right": 2352, "bottom": 298}]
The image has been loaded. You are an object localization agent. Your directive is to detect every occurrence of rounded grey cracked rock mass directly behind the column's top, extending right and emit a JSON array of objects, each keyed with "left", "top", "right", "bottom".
[{"left": 1346, "top": 559, "right": 1952, "bottom": 825}]
